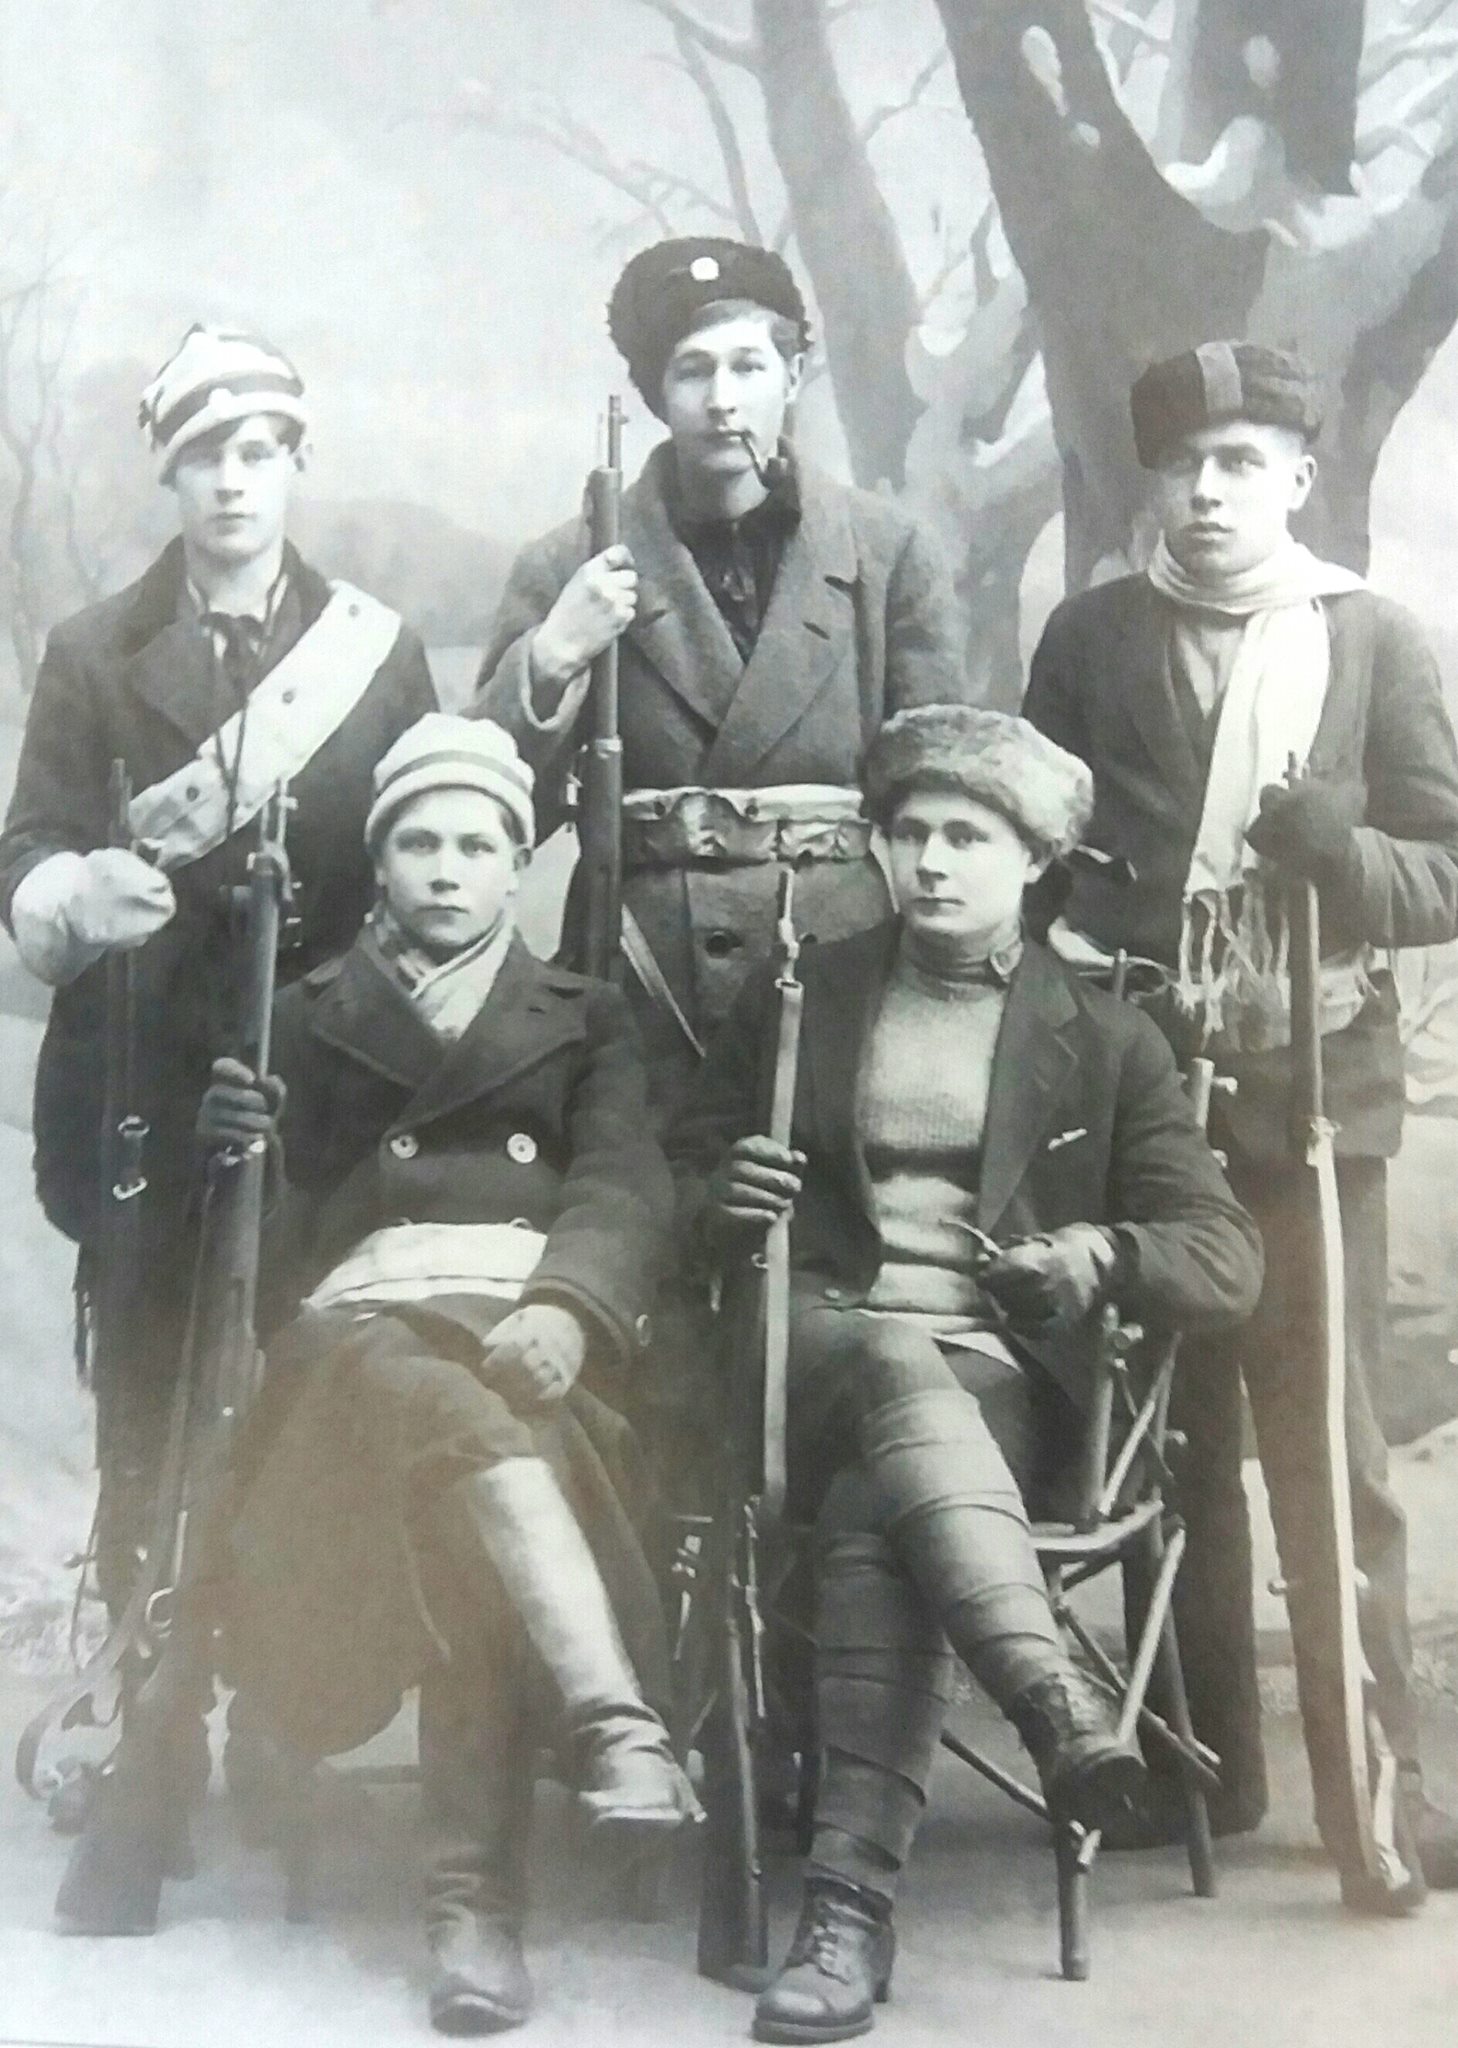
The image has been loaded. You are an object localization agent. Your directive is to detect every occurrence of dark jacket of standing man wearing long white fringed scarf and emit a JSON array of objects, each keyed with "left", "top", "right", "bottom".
[{"left": 1022, "top": 575, "right": 1458, "bottom": 1157}]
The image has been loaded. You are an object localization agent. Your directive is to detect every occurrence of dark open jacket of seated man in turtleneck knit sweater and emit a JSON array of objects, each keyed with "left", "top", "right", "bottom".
[{"left": 670, "top": 924, "right": 1261, "bottom": 1401}]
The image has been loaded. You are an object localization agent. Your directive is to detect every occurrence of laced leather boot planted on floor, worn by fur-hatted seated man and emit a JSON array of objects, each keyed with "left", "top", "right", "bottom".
[{"left": 754, "top": 1878, "right": 897, "bottom": 2042}]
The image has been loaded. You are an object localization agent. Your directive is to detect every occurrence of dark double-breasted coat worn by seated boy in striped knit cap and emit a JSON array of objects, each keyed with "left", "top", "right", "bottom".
[{"left": 227, "top": 940, "right": 672, "bottom": 1753}]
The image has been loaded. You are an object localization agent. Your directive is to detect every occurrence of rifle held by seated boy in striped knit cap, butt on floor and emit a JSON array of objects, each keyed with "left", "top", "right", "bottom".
[{"left": 55, "top": 791, "right": 289, "bottom": 1935}]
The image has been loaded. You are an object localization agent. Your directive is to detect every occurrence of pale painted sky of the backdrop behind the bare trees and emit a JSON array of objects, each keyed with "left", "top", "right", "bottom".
[{"left": 0, "top": 0, "right": 1458, "bottom": 666}]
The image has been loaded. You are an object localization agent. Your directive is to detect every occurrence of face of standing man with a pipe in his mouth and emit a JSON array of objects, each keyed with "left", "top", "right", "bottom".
[{"left": 663, "top": 313, "right": 801, "bottom": 479}]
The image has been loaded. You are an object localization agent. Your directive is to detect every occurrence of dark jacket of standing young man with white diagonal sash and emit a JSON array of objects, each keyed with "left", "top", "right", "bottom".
[{"left": 0, "top": 541, "right": 436, "bottom": 1241}]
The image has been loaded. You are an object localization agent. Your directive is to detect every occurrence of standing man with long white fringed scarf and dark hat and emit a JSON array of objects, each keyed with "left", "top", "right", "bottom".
[{"left": 1024, "top": 342, "right": 1458, "bottom": 1903}]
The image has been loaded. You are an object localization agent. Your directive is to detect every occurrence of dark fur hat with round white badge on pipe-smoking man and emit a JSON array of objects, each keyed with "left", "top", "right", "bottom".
[{"left": 608, "top": 236, "right": 809, "bottom": 420}]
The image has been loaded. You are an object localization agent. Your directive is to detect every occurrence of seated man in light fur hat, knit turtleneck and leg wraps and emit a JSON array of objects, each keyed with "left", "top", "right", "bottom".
[{"left": 670, "top": 705, "right": 1261, "bottom": 2040}]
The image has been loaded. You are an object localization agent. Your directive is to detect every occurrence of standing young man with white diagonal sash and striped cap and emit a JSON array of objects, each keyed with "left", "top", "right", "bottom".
[{"left": 0, "top": 326, "right": 434, "bottom": 1612}]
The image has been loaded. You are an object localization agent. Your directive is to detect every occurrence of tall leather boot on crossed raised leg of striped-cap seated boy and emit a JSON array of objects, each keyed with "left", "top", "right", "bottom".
[{"left": 436, "top": 1458, "right": 698, "bottom": 1835}]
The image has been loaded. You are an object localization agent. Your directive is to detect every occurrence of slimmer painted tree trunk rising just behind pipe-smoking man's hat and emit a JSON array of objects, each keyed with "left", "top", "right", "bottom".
[{"left": 754, "top": 0, "right": 921, "bottom": 489}]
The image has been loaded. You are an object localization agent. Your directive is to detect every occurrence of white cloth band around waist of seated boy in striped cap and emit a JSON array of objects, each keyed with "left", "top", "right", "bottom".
[{"left": 307, "top": 1223, "right": 547, "bottom": 1311}]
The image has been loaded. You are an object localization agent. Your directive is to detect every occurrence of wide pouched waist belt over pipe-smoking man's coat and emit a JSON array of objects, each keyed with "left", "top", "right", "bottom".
[{"left": 623, "top": 782, "right": 870, "bottom": 868}]
